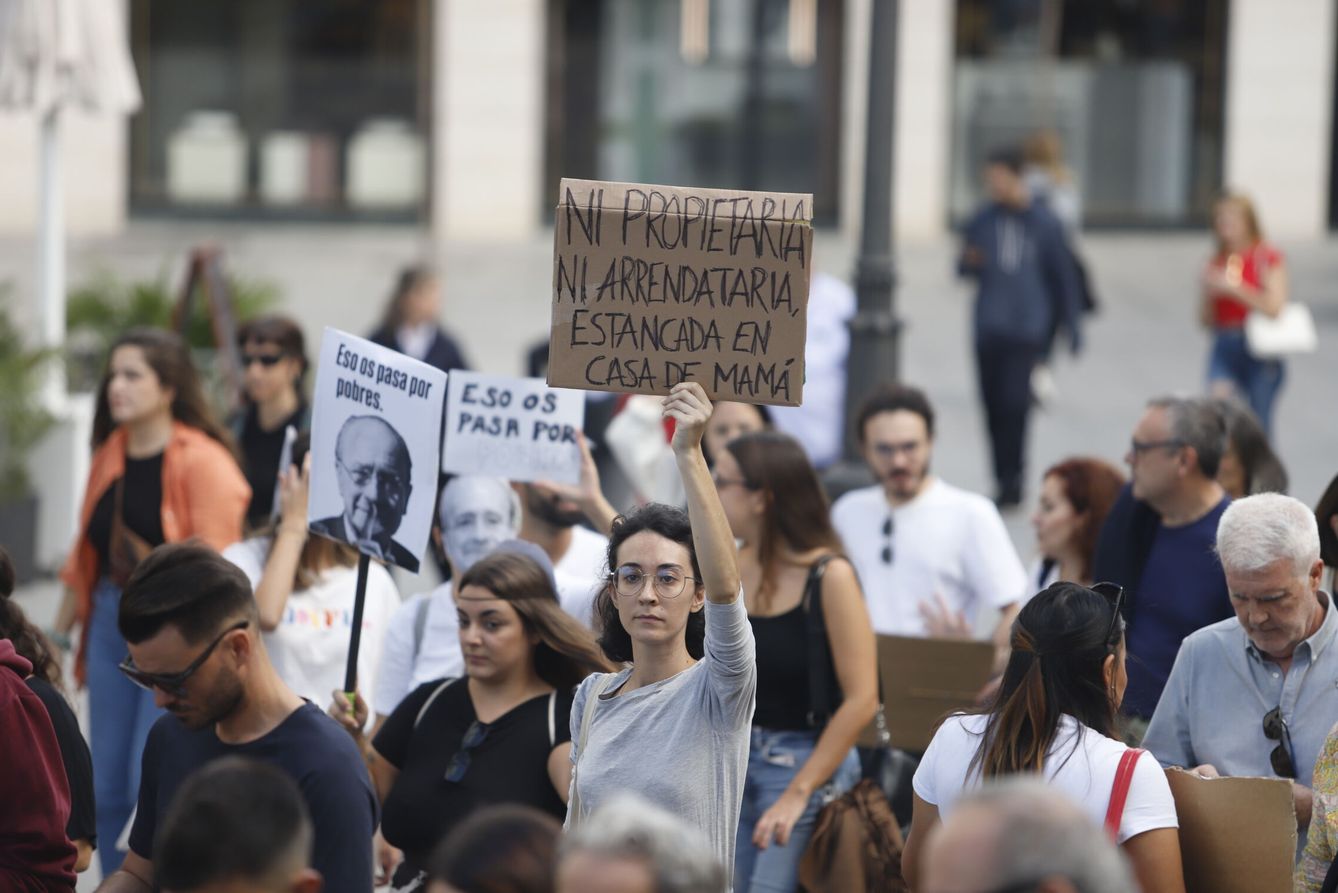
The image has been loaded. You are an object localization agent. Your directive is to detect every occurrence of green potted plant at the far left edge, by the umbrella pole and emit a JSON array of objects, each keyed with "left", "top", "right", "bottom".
[{"left": 0, "top": 289, "right": 55, "bottom": 581}]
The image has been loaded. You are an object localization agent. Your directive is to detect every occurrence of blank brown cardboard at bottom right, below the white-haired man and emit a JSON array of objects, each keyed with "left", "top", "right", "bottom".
[{"left": 1161, "top": 771, "right": 1297, "bottom": 893}]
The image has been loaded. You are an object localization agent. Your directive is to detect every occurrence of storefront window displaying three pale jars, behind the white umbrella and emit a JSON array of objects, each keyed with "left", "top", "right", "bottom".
[{"left": 130, "top": 0, "right": 431, "bottom": 220}]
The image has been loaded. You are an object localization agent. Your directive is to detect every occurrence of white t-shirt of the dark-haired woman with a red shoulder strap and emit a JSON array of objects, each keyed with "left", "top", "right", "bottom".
[{"left": 911, "top": 715, "right": 1180, "bottom": 843}]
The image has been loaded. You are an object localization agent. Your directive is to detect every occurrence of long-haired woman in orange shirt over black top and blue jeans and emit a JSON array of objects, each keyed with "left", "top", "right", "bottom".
[{"left": 55, "top": 328, "right": 250, "bottom": 874}]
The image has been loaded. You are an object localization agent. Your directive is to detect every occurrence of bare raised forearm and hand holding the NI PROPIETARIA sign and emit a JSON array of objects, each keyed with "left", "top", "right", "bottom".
[{"left": 664, "top": 382, "right": 739, "bottom": 605}]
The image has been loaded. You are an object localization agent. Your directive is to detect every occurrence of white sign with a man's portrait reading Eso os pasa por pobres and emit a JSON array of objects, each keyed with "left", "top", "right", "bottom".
[{"left": 308, "top": 328, "right": 446, "bottom": 573}]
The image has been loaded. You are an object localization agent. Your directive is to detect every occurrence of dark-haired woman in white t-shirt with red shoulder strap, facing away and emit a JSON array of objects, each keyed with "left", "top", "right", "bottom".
[{"left": 902, "top": 582, "right": 1184, "bottom": 893}]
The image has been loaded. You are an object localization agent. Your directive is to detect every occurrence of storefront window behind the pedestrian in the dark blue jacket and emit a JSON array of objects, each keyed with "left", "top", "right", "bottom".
[{"left": 950, "top": 0, "right": 1227, "bottom": 225}]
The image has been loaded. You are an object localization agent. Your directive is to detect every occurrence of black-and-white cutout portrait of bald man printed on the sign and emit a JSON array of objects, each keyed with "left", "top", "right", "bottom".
[{"left": 312, "top": 415, "right": 419, "bottom": 573}]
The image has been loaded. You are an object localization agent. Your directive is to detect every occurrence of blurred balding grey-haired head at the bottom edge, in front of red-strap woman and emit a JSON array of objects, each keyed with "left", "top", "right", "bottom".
[{"left": 917, "top": 777, "right": 1137, "bottom": 893}]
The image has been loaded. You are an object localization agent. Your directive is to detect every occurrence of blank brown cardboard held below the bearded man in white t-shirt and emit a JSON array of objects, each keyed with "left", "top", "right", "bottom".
[{"left": 859, "top": 636, "right": 994, "bottom": 752}]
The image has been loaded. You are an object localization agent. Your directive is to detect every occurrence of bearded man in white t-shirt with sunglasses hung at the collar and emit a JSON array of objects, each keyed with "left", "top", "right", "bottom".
[{"left": 832, "top": 384, "right": 1029, "bottom": 668}]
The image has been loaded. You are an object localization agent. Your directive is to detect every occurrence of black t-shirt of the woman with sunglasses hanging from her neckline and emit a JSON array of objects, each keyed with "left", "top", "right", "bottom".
[{"left": 372, "top": 679, "right": 574, "bottom": 878}]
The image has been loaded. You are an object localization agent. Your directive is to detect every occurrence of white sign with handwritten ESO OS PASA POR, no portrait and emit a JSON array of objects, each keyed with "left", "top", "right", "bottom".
[{"left": 442, "top": 372, "right": 585, "bottom": 483}]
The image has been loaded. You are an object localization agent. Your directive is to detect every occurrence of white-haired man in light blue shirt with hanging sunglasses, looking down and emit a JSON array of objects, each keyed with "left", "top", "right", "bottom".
[{"left": 1143, "top": 493, "right": 1338, "bottom": 843}]
